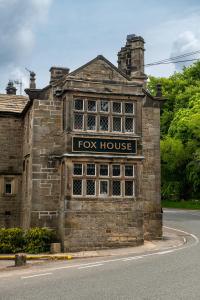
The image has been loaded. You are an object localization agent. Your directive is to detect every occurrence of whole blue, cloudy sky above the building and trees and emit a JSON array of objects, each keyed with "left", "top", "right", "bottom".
[{"left": 0, "top": 0, "right": 200, "bottom": 93}]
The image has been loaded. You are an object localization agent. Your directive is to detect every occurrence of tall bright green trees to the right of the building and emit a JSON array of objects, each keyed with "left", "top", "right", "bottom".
[{"left": 148, "top": 62, "right": 200, "bottom": 199}]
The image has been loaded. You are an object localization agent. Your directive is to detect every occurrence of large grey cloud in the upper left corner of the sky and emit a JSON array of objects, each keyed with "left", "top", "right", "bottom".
[{"left": 0, "top": 0, "right": 53, "bottom": 92}]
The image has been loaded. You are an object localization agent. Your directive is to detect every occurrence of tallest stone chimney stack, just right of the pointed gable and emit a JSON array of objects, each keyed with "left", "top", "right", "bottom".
[{"left": 118, "top": 34, "right": 146, "bottom": 80}]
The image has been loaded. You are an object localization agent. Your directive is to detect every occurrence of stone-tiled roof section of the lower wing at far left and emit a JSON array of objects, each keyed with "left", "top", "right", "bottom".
[{"left": 0, "top": 94, "right": 29, "bottom": 113}]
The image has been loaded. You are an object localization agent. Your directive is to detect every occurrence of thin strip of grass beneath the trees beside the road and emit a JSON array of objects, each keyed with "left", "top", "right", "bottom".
[{"left": 162, "top": 200, "right": 200, "bottom": 209}]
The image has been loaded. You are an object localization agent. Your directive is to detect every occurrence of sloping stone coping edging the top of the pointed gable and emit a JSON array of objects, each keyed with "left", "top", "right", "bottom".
[{"left": 68, "top": 55, "right": 130, "bottom": 80}]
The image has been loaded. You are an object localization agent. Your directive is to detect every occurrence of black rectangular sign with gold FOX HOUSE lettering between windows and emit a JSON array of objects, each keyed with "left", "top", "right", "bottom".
[{"left": 72, "top": 137, "right": 136, "bottom": 154}]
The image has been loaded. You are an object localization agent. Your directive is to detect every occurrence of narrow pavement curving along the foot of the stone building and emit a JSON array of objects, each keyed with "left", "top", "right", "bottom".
[{"left": 0, "top": 227, "right": 186, "bottom": 271}]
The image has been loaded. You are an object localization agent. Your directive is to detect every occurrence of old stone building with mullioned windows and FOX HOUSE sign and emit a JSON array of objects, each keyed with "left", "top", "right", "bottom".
[{"left": 0, "top": 35, "right": 162, "bottom": 251}]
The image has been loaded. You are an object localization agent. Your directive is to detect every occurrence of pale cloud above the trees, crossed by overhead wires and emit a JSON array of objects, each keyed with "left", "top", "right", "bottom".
[{"left": 171, "top": 30, "right": 200, "bottom": 71}]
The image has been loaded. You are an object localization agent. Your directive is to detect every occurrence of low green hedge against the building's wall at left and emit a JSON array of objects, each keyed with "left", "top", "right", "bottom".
[{"left": 0, "top": 227, "right": 56, "bottom": 254}]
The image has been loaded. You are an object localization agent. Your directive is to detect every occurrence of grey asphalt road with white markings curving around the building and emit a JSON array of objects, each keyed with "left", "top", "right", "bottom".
[{"left": 0, "top": 210, "right": 200, "bottom": 300}]
